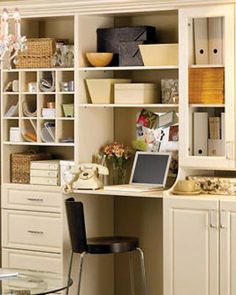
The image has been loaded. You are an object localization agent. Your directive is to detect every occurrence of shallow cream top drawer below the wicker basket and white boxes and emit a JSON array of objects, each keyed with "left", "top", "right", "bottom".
[{"left": 2, "top": 187, "right": 62, "bottom": 212}]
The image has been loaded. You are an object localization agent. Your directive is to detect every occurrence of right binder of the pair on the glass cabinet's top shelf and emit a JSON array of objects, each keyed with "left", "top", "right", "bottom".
[{"left": 208, "top": 17, "right": 223, "bottom": 65}]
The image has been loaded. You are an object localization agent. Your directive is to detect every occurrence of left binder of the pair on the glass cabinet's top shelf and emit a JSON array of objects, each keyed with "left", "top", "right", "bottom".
[{"left": 194, "top": 18, "right": 209, "bottom": 64}]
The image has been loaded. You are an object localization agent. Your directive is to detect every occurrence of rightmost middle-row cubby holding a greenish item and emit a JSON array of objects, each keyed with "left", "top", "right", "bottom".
[{"left": 56, "top": 94, "right": 74, "bottom": 118}]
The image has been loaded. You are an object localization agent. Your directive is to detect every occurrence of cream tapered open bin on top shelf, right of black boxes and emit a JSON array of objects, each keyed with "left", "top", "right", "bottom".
[{"left": 139, "top": 43, "right": 179, "bottom": 66}]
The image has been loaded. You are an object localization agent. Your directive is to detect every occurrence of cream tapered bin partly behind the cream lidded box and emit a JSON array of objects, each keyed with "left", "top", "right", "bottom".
[{"left": 86, "top": 79, "right": 131, "bottom": 104}]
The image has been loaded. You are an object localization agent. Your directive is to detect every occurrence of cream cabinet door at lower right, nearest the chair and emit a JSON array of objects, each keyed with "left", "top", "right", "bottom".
[{"left": 163, "top": 197, "right": 219, "bottom": 295}]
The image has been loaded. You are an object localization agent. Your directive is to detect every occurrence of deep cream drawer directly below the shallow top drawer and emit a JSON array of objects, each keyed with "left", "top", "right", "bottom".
[{"left": 2, "top": 209, "right": 63, "bottom": 253}]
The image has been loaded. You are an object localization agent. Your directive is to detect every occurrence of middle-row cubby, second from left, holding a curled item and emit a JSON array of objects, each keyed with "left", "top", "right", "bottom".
[{"left": 19, "top": 94, "right": 38, "bottom": 117}]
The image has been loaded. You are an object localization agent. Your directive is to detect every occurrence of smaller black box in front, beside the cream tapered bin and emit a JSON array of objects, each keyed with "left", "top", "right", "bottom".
[{"left": 119, "top": 41, "right": 144, "bottom": 66}]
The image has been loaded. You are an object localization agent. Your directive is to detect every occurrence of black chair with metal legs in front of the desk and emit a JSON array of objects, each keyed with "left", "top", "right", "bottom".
[{"left": 65, "top": 198, "right": 147, "bottom": 295}]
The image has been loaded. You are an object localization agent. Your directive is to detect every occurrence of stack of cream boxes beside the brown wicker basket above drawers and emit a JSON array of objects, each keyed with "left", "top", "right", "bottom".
[{"left": 30, "top": 160, "right": 60, "bottom": 185}]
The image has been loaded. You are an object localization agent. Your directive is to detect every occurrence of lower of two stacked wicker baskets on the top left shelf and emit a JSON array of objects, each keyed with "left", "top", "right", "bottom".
[{"left": 15, "top": 53, "right": 52, "bottom": 69}]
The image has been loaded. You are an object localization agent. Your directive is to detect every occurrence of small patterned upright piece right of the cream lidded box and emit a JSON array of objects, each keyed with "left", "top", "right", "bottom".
[{"left": 161, "top": 79, "right": 179, "bottom": 104}]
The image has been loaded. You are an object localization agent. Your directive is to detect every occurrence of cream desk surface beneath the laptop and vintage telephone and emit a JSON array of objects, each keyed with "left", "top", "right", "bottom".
[{"left": 73, "top": 189, "right": 165, "bottom": 198}]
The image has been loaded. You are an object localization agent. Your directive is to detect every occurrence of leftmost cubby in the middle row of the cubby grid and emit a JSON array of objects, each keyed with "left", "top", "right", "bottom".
[{"left": 2, "top": 94, "right": 19, "bottom": 118}]
